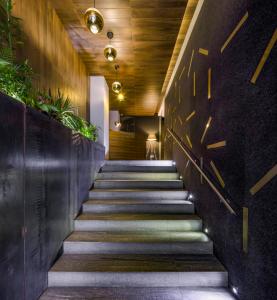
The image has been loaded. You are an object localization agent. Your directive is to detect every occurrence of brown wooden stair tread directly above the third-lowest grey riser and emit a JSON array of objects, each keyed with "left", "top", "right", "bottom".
[{"left": 77, "top": 213, "right": 200, "bottom": 221}]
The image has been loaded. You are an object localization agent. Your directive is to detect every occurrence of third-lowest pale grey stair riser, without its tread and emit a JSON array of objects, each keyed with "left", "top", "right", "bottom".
[{"left": 74, "top": 220, "right": 202, "bottom": 231}]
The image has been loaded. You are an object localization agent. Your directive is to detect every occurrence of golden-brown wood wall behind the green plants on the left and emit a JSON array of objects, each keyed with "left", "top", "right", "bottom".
[{"left": 13, "top": 0, "right": 88, "bottom": 117}]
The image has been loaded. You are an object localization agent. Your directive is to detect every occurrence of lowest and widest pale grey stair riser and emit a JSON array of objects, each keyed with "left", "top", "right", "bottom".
[{"left": 48, "top": 272, "right": 228, "bottom": 287}]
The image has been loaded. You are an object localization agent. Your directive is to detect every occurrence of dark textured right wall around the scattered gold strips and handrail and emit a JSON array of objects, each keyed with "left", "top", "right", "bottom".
[{"left": 165, "top": 0, "right": 277, "bottom": 300}]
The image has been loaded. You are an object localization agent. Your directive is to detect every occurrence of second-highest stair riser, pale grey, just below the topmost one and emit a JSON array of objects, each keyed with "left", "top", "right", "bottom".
[{"left": 96, "top": 172, "right": 179, "bottom": 180}]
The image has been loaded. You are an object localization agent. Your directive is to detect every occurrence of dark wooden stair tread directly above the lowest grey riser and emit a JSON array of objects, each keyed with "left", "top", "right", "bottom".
[{"left": 50, "top": 254, "right": 226, "bottom": 272}]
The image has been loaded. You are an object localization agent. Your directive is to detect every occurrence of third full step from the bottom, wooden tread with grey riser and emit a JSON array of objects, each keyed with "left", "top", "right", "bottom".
[{"left": 74, "top": 213, "right": 202, "bottom": 231}]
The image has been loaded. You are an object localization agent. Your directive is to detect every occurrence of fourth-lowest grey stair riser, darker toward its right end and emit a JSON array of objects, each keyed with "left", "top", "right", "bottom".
[{"left": 83, "top": 204, "right": 194, "bottom": 214}]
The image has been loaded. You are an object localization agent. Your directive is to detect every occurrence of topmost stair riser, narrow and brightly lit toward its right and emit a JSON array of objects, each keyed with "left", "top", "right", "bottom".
[{"left": 104, "top": 160, "right": 174, "bottom": 167}]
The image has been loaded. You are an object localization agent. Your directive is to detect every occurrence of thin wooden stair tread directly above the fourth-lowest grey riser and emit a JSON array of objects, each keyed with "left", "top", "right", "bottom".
[{"left": 84, "top": 199, "right": 192, "bottom": 205}]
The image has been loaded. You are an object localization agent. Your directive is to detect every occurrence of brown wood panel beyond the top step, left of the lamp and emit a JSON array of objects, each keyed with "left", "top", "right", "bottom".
[{"left": 109, "top": 130, "right": 146, "bottom": 160}]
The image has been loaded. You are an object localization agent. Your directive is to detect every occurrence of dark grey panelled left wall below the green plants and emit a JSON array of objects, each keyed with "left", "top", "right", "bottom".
[{"left": 0, "top": 94, "right": 104, "bottom": 300}]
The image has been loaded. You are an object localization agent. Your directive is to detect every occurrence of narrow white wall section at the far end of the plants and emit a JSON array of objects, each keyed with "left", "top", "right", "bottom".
[{"left": 90, "top": 76, "right": 109, "bottom": 154}]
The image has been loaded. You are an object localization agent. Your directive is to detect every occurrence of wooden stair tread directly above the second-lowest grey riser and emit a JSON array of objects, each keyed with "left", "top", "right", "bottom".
[{"left": 66, "top": 231, "right": 210, "bottom": 243}]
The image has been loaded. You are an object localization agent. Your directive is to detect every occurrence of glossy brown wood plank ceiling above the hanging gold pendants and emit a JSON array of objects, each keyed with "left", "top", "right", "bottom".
[{"left": 49, "top": 0, "right": 187, "bottom": 116}]
